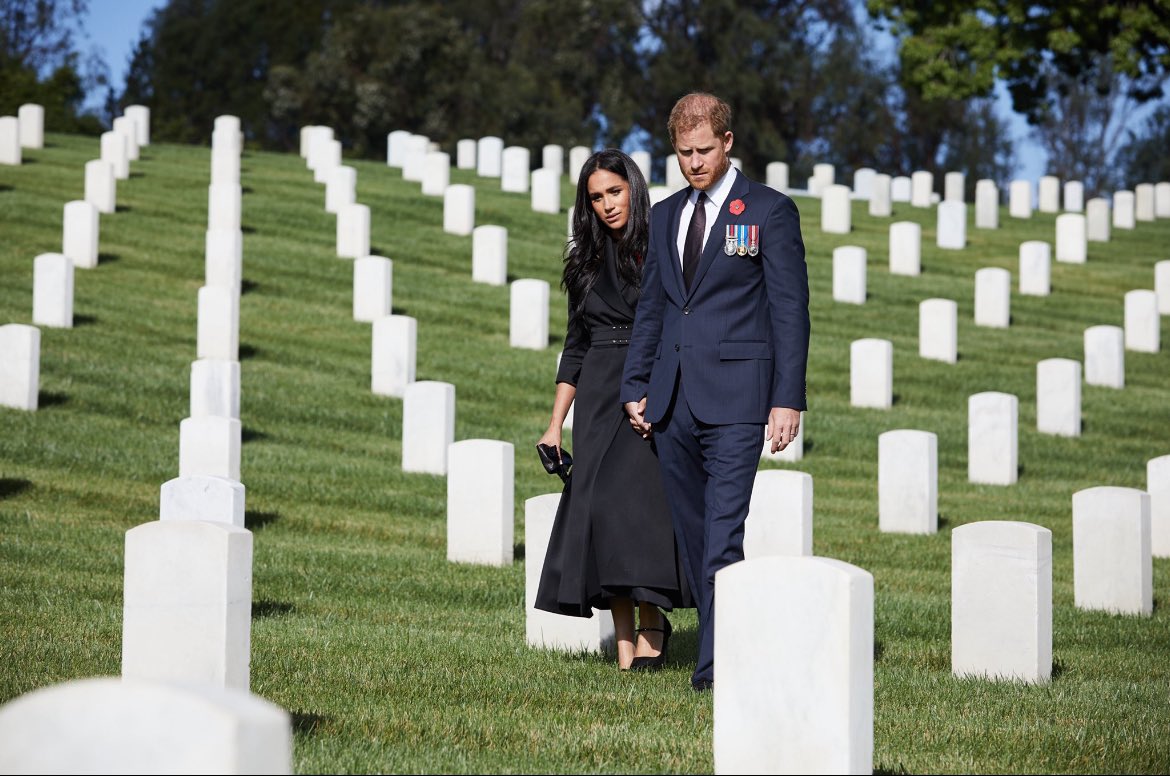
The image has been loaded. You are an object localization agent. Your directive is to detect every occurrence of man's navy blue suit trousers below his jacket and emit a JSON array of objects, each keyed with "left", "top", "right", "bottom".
[{"left": 654, "top": 377, "right": 764, "bottom": 682}]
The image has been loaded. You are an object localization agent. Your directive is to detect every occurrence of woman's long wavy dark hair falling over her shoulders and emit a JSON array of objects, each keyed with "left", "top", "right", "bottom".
[{"left": 560, "top": 149, "right": 651, "bottom": 325}]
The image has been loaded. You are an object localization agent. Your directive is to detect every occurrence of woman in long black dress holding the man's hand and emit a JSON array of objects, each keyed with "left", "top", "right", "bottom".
[{"left": 536, "top": 149, "right": 694, "bottom": 669}]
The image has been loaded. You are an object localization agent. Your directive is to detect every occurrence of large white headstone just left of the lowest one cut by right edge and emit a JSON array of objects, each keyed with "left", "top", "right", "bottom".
[{"left": 1073, "top": 486, "right": 1154, "bottom": 616}]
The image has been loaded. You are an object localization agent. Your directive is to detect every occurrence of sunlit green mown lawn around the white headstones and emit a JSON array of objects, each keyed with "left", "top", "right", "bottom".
[{"left": 0, "top": 133, "right": 1170, "bottom": 774}]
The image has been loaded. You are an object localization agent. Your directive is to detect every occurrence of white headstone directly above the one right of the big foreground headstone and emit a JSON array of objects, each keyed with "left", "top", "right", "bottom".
[{"left": 966, "top": 391, "right": 1019, "bottom": 485}]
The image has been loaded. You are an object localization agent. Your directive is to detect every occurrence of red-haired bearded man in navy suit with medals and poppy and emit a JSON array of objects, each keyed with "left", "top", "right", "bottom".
[{"left": 621, "top": 94, "right": 808, "bottom": 691}]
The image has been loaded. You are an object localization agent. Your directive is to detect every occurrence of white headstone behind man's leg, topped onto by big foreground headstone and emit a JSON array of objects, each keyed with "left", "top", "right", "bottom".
[{"left": 743, "top": 469, "right": 812, "bottom": 559}]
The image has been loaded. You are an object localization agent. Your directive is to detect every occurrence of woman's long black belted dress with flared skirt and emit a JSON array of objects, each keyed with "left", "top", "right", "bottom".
[{"left": 536, "top": 239, "right": 694, "bottom": 617}]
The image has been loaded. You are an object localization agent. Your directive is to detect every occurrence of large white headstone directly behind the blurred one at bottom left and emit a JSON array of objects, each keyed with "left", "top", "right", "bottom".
[{"left": 122, "top": 520, "right": 252, "bottom": 689}]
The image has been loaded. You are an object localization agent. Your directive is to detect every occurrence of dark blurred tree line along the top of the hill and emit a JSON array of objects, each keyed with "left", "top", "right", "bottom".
[{"left": 0, "top": 0, "right": 1170, "bottom": 194}]
